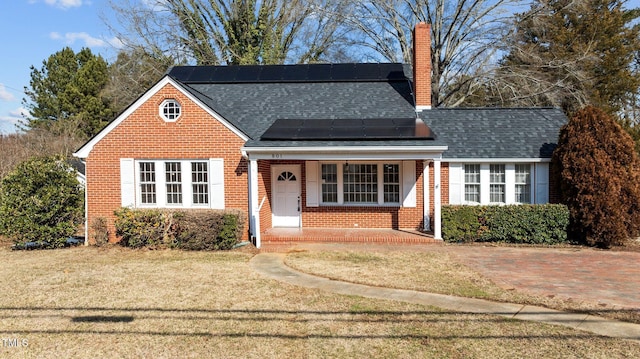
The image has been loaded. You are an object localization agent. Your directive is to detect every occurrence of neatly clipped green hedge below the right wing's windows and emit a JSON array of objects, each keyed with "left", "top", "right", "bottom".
[{"left": 442, "top": 204, "right": 569, "bottom": 244}]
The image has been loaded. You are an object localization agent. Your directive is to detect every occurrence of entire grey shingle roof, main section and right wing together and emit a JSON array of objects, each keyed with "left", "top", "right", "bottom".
[{"left": 168, "top": 64, "right": 567, "bottom": 159}]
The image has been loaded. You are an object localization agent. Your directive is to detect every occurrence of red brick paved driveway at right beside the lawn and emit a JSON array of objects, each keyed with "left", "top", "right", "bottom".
[{"left": 442, "top": 246, "right": 640, "bottom": 309}]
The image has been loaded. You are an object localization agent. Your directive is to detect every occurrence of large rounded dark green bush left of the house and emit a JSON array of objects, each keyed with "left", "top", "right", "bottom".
[{"left": 0, "top": 157, "right": 84, "bottom": 248}]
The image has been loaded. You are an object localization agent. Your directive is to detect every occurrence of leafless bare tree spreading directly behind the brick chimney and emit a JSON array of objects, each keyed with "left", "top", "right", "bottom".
[{"left": 349, "top": 0, "right": 525, "bottom": 107}]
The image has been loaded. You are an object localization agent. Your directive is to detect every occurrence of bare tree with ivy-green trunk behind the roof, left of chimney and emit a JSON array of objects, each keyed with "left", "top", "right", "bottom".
[{"left": 106, "top": 0, "right": 356, "bottom": 65}]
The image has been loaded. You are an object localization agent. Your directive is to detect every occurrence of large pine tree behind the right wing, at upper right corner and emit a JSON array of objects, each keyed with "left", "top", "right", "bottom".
[{"left": 496, "top": 0, "right": 640, "bottom": 114}]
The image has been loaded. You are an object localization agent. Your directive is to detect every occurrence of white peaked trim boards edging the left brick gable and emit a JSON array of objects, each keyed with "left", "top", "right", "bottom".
[{"left": 73, "top": 76, "right": 249, "bottom": 158}]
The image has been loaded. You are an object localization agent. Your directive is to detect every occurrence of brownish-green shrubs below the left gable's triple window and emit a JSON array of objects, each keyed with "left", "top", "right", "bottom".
[{"left": 115, "top": 208, "right": 245, "bottom": 250}]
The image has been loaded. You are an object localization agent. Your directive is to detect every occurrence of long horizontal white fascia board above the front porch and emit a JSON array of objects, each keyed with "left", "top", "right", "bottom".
[{"left": 242, "top": 146, "right": 448, "bottom": 160}]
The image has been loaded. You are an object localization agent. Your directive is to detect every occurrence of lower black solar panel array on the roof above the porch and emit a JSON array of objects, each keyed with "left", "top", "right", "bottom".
[{"left": 261, "top": 118, "right": 435, "bottom": 141}]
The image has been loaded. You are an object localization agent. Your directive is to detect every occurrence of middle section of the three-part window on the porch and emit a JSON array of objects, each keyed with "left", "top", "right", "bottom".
[{"left": 342, "top": 164, "right": 378, "bottom": 203}]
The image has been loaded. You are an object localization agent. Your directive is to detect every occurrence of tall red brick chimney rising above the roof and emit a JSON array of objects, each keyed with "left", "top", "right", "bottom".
[{"left": 413, "top": 22, "right": 431, "bottom": 111}]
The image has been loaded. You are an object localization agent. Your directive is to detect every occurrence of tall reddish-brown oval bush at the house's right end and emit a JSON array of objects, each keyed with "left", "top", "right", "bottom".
[{"left": 552, "top": 107, "right": 640, "bottom": 247}]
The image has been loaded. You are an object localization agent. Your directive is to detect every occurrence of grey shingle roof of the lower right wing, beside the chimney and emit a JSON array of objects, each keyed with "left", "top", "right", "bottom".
[{"left": 420, "top": 108, "right": 567, "bottom": 159}]
